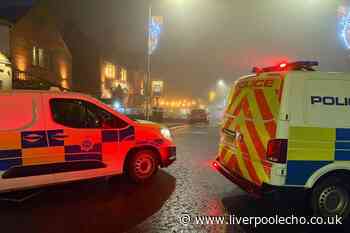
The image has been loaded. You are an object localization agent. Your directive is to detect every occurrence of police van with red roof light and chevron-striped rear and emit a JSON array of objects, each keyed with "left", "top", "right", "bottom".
[{"left": 213, "top": 61, "right": 350, "bottom": 217}]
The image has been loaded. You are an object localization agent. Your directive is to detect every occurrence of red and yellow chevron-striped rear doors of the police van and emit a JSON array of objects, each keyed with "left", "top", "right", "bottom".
[{"left": 218, "top": 73, "right": 284, "bottom": 185}]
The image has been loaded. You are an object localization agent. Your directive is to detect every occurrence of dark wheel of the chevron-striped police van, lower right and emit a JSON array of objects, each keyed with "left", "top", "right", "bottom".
[{"left": 311, "top": 176, "right": 350, "bottom": 219}]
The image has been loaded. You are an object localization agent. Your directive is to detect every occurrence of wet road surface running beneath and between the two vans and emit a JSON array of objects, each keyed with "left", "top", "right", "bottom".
[{"left": 0, "top": 126, "right": 346, "bottom": 233}]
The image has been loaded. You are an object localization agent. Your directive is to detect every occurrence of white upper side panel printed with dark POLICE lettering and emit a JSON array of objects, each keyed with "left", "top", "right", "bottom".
[{"left": 303, "top": 79, "right": 350, "bottom": 128}]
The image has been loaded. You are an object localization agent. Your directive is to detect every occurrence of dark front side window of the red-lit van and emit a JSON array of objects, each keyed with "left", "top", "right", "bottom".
[{"left": 50, "top": 99, "right": 128, "bottom": 129}]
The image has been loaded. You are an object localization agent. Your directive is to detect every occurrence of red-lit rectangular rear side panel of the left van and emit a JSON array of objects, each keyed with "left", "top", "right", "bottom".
[{"left": 0, "top": 95, "right": 35, "bottom": 131}]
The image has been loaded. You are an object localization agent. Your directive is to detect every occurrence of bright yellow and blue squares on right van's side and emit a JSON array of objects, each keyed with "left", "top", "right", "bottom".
[{"left": 286, "top": 127, "right": 350, "bottom": 186}]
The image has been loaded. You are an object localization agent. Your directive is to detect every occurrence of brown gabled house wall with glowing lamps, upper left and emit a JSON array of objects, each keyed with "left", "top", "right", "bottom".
[{"left": 10, "top": 2, "right": 72, "bottom": 88}]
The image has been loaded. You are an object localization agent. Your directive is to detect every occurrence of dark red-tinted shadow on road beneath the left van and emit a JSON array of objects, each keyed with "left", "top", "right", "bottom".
[{"left": 0, "top": 171, "right": 175, "bottom": 233}]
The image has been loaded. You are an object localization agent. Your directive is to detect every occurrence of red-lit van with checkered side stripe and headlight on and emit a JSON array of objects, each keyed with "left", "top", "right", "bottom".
[{"left": 0, "top": 91, "right": 176, "bottom": 192}]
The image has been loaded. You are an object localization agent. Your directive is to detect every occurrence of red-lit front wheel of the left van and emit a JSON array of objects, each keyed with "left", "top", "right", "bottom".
[{"left": 127, "top": 150, "right": 159, "bottom": 183}]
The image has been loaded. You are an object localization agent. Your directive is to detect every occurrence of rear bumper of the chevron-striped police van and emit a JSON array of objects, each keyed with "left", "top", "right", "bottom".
[{"left": 215, "top": 161, "right": 306, "bottom": 198}]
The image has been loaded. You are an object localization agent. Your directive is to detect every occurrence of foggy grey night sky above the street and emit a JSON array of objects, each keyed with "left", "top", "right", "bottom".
[{"left": 0, "top": 0, "right": 350, "bottom": 96}]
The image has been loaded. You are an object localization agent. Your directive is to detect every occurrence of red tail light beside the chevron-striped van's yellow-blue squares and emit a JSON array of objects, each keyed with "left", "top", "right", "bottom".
[{"left": 266, "top": 139, "right": 288, "bottom": 163}]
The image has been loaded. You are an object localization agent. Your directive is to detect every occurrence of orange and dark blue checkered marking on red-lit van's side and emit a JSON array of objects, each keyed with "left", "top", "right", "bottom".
[{"left": 0, "top": 126, "right": 135, "bottom": 171}]
